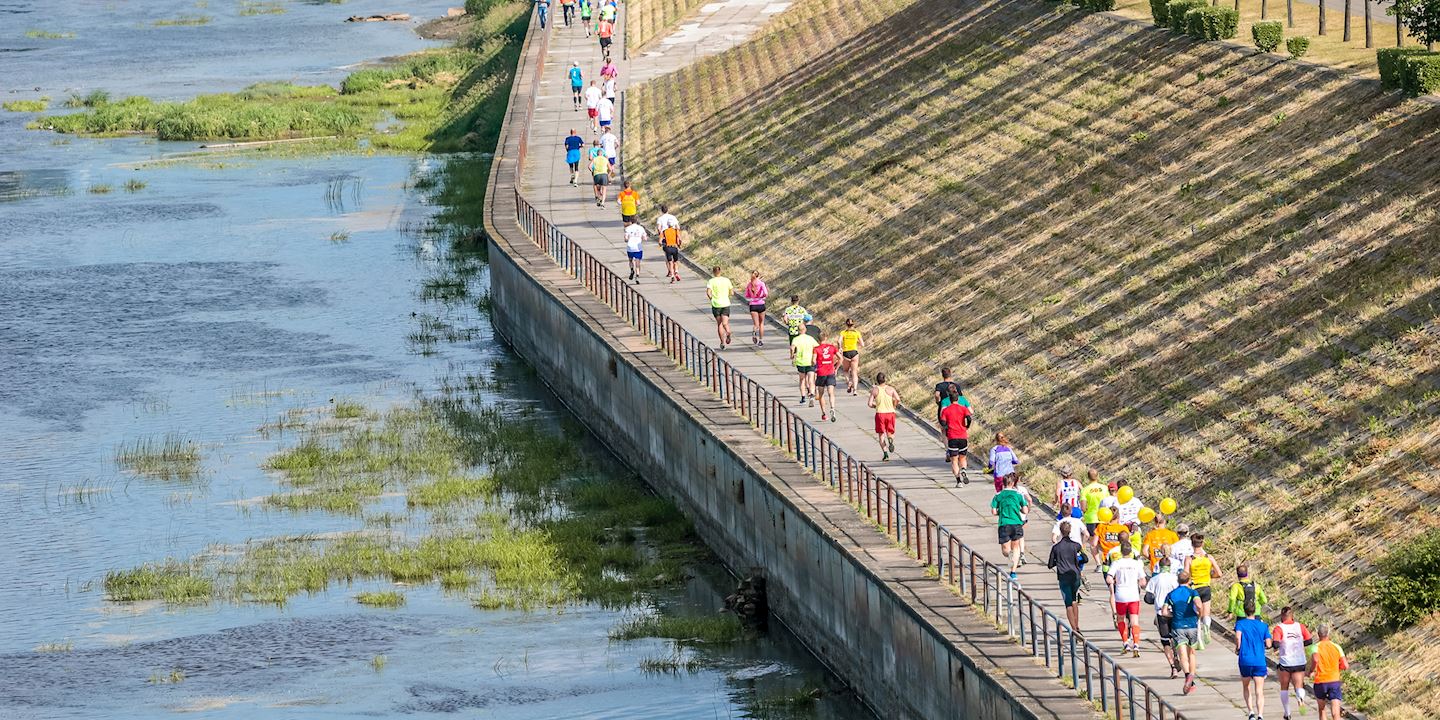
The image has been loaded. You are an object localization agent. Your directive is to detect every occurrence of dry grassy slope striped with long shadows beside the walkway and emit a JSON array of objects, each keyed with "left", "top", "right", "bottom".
[{"left": 626, "top": 0, "right": 1440, "bottom": 717}]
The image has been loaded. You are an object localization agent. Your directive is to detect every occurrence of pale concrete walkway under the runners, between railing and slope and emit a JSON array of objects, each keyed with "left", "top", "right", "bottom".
[{"left": 521, "top": 7, "right": 1261, "bottom": 719}]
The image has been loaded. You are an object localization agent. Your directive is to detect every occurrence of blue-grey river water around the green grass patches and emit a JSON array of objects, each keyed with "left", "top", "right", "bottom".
[{"left": 0, "top": 0, "right": 871, "bottom": 719}]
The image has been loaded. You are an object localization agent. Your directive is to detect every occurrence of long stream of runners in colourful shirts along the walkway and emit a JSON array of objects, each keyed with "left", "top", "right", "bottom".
[{"left": 547, "top": 9, "right": 1346, "bottom": 720}]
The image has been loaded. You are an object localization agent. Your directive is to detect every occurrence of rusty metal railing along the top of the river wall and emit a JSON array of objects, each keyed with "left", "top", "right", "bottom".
[{"left": 514, "top": 190, "right": 1184, "bottom": 720}]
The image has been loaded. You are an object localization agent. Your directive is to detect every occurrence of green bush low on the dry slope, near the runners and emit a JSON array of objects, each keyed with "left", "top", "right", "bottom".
[{"left": 1367, "top": 527, "right": 1440, "bottom": 628}]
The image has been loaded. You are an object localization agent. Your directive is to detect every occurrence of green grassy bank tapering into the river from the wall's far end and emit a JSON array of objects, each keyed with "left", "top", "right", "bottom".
[{"left": 32, "top": 1, "right": 528, "bottom": 153}]
